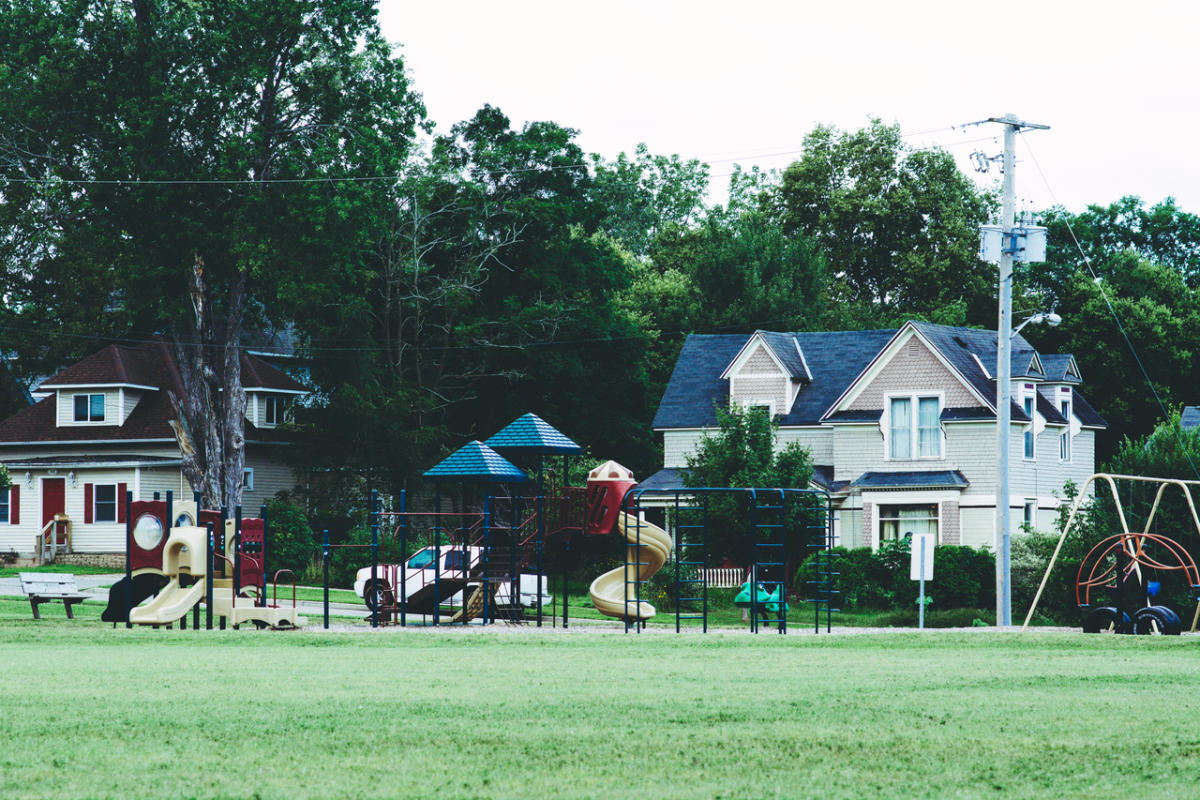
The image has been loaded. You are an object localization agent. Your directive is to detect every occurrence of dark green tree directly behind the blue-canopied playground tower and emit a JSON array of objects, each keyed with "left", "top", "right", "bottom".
[{"left": 299, "top": 107, "right": 658, "bottom": 489}]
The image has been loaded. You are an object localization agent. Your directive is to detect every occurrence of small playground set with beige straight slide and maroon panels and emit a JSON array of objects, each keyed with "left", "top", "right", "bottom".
[{"left": 101, "top": 492, "right": 305, "bottom": 628}]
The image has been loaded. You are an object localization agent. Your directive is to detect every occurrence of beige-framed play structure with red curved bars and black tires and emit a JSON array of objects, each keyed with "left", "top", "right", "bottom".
[{"left": 1021, "top": 473, "right": 1200, "bottom": 634}]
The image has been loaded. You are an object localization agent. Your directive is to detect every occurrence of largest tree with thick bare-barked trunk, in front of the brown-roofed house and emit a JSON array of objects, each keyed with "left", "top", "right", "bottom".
[{"left": 0, "top": 0, "right": 424, "bottom": 505}]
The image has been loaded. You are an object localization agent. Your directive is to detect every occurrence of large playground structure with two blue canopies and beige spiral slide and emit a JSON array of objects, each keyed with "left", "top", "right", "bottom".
[{"left": 348, "top": 414, "right": 836, "bottom": 633}]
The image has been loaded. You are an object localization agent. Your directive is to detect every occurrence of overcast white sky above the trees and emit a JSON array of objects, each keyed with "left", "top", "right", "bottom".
[{"left": 380, "top": 0, "right": 1200, "bottom": 212}]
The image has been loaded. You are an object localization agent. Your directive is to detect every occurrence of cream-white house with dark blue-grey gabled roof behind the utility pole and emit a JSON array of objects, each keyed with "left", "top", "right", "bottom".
[{"left": 642, "top": 321, "right": 1106, "bottom": 547}]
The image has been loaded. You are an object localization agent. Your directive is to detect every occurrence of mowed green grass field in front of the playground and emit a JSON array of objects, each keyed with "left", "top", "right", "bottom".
[{"left": 0, "top": 609, "right": 1200, "bottom": 800}]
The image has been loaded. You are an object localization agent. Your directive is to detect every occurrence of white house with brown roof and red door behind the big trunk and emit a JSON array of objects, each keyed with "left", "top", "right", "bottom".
[{"left": 0, "top": 338, "right": 307, "bottom": 555}]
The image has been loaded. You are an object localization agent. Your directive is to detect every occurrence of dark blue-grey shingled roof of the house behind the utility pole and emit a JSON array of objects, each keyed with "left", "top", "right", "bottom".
[{"left": 653, "top": 321, "right": 1108, "bottom": 429}]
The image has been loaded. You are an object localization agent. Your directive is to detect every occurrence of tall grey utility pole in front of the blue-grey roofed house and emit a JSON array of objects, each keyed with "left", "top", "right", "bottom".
[{"left": 986, "top": 114, "right": 1050, "bottom": 627}]
